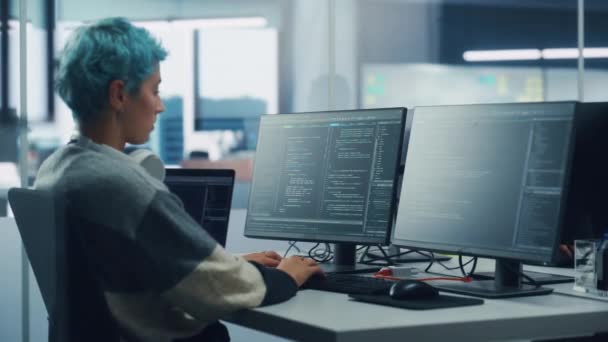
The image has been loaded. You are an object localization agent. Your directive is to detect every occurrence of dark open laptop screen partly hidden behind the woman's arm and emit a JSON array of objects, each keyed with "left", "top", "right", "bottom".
[{"left": 165, "top": 168, "right": 234, "bottom": 247}]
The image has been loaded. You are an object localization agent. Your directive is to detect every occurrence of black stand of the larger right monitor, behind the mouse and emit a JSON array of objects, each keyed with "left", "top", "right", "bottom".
[{"left": 434, "top": 259, "right": 553, "bottom": 298}]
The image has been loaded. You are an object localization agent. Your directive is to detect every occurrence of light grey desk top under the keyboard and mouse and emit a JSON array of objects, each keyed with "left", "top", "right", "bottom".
[{"left": 226, "top": 260, "right": 608, "bottom": 341}]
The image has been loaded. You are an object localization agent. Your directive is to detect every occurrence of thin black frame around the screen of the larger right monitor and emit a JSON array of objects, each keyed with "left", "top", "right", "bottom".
[{"left": 391, "top": 101, "right": 579, "bottom": 263}]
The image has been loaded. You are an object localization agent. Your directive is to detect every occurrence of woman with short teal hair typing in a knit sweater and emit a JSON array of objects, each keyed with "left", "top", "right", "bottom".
[{"left": 35, "top": 18, "right": 321, "bottom": 341}]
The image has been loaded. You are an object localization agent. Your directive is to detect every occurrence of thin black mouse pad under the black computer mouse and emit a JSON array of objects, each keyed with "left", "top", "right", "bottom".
[{"left": 349, "top": 294, "right": 483, "bottom": 310}]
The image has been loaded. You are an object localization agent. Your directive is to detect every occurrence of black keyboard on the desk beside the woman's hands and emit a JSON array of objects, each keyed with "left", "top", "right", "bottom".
[{"left": 302, "top": 273, "right": 394, "bottom": 294}]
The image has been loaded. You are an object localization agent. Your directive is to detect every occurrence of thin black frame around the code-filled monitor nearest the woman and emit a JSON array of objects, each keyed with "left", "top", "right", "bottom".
[{"left": 244, "top": 107, "right": 408, "bottom": 245}]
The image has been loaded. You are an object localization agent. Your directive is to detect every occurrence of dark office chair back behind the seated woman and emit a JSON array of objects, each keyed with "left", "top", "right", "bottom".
[{"left": 8, "top": 188, "right": 120, "bottom": 342}]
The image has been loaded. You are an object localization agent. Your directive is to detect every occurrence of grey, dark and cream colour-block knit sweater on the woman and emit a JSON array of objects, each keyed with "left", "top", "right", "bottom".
[{"left": 35, "top": 137, "right": 297, "bottom": 342}]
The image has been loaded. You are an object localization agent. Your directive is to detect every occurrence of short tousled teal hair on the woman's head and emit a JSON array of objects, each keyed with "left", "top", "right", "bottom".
[{"left": 56, "top": 18, "right": 167, "bottom": 124}]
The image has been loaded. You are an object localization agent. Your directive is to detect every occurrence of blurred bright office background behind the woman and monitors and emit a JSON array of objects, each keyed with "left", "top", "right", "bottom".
[{"left": 0, "top": 0, "right": 608, "bottom": 341}]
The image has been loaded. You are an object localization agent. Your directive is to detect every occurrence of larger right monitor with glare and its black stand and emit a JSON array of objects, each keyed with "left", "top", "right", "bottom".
[{"left": 392, "top": 102, "right": 579, "bottom": 297}]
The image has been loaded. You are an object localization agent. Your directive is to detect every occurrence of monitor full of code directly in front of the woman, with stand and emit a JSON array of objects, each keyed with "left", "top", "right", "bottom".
[{"left": 245, "top": 108, "right": 406, "bottom": 272}]
